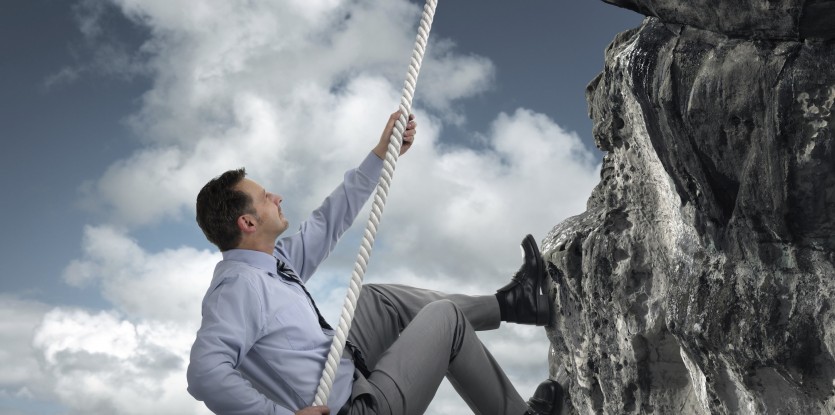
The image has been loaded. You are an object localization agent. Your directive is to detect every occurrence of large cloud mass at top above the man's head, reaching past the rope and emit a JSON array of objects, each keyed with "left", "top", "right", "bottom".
[{"left": 76, "top": 0, "right": 493, "bottom": 226}]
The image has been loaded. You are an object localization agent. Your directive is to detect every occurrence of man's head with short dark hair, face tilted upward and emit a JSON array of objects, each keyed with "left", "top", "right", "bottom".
[{"left": 197, "top": 168, "right": 288, "bottom": 252}]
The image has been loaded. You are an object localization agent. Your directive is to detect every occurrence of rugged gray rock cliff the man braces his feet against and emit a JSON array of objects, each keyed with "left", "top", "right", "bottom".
[{"left": 541, "top": 0, "right": 835, "bottom": 414}]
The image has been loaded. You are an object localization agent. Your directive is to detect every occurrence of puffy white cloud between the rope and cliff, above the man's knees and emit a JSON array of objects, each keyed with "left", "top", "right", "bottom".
[{"left": 360, "top": 109, "right": 598, "bottom": 287}]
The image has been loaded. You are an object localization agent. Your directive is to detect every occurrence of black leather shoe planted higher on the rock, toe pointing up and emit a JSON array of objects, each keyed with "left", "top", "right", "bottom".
[{"left": 496, "top": 235, "right": 553, "bottom": 326}]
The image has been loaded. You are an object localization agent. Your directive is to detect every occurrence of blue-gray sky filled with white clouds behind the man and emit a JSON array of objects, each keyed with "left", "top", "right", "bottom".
[{"left": 0, "top": 0, "right": 642, "bottom": 415}]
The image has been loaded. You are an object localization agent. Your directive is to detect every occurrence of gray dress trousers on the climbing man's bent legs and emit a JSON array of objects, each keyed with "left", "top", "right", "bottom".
[{"left": 346, "top": 284, "right": 528, "bottom": 415}]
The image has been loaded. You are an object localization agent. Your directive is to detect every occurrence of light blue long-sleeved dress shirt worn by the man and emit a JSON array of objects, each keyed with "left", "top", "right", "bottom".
[{"left": 187, "top": 153, "right": 383, "bottom": 414}]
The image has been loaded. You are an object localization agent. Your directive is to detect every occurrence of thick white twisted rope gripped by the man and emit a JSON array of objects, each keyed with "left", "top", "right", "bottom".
[{"left": 313, "top": 0, "right": 438, "bottom": 406}]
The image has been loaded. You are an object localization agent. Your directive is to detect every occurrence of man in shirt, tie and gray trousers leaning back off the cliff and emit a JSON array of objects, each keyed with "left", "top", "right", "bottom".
[{"left": 188, "top": 112, "right": 561, "bottom": 415}]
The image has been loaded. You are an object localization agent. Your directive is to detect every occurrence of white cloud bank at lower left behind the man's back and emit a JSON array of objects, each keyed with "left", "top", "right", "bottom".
[{"left": 0, "top": 226, "right": 219, "bottom": 414}]
